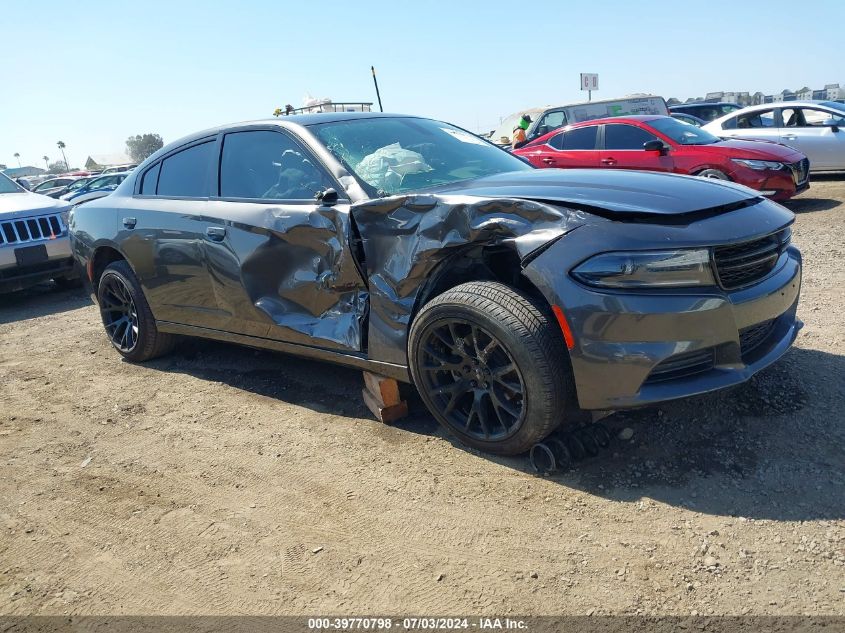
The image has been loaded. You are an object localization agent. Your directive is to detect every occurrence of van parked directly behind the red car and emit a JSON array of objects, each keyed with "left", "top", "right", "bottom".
[{"left": 490, "top": 95, "right": 669, "bottom": 145}]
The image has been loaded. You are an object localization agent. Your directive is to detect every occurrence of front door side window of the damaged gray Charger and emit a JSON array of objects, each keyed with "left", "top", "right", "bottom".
[{"left": 219, "top": 130, "right": 336, "bottom": 200}]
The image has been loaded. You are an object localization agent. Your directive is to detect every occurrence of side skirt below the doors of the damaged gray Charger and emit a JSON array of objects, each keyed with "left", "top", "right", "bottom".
[{"left": 156, "top": 321, "right": 411, "bottom": 383}]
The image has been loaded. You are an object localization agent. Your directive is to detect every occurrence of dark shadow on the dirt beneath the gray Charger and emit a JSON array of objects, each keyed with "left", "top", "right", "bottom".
[{"left": 148, "top": 340, "right": 845, "bottom": 521}]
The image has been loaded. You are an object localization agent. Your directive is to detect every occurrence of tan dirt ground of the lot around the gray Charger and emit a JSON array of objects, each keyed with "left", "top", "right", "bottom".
[{"left": 0, "top": 177, "right": 845, "bottom": 616}]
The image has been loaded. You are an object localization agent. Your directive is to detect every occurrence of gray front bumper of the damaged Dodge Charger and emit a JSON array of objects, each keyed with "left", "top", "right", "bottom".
[{"left": 528, "top": 238, "right": 802, "bottom": 410}]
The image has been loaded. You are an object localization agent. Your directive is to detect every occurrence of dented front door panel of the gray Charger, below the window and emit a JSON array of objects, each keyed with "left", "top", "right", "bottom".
[{"left": 205, "top": 201, "right": 368, "bottom": 352}]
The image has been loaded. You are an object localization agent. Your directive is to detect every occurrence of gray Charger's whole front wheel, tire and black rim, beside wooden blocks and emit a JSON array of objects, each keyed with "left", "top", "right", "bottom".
[{"left": 409, "top": 282, "right": 574, "bottom": 455}]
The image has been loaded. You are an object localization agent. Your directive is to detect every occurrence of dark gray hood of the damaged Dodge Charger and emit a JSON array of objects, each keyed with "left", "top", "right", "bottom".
[{"left": 431, "top": 169, "right": 760, "bottom": 222}]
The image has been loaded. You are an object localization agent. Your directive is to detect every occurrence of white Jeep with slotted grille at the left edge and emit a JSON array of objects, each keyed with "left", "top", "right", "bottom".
[{"left": 0, "top": 174, "right": 79, "bottom": 293}]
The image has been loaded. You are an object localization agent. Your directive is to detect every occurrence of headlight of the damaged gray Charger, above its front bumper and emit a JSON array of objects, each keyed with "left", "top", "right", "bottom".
[{"left": 571, "top": 249, "right": 716, "bottom": 288}]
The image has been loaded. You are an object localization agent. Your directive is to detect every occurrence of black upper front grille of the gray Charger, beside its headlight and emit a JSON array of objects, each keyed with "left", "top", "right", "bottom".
[{"left": 713, "top": 227, "right": 792, "bottom": 290}]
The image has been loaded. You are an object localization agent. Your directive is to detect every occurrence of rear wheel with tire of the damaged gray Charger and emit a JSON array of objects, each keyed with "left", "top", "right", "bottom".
[{"left": 97, "top": 260, "right": 176, "bottom": 363}]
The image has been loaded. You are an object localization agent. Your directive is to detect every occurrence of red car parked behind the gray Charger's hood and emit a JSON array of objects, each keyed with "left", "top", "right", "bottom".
[{"left": 514, "top": 115, "right": 810, "bottom": 200}]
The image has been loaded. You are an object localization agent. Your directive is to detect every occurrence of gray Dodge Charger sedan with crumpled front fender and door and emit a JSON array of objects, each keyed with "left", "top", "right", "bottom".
[{"left": 70, "top": 113, "right": 801, "bottom": 454}]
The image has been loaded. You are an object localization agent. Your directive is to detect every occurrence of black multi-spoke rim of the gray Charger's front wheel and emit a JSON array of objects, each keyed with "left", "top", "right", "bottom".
[{"left": 419, "top": 319, "right": 525, "bottom": 442}]
